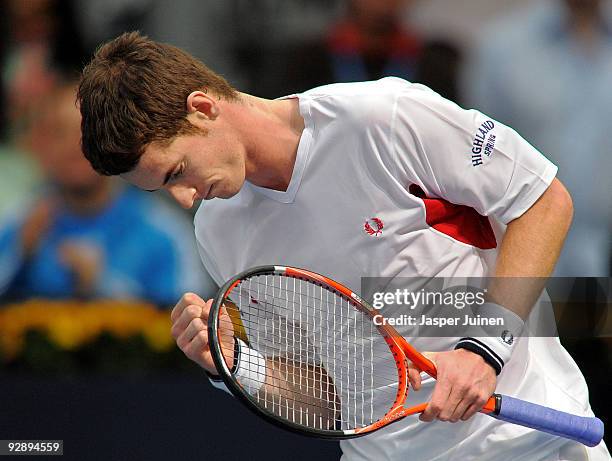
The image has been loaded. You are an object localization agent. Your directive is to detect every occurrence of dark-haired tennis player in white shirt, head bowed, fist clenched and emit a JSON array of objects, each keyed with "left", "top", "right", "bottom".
[{"left": 79, "top": 33, "right": 607, "bottom": 461}]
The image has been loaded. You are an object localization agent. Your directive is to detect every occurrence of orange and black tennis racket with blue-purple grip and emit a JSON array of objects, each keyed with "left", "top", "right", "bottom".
[{"left": 208, "top": 266, "right": 603, "bottom": 446}]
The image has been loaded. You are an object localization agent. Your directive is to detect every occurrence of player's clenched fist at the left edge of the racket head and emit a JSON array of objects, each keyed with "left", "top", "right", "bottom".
[{"left": 170, "top": 293, "right": 234, "bottom": 375}]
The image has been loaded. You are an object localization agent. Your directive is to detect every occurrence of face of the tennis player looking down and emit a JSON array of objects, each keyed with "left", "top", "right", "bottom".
[{"left": 121, "top": 120, "right": 246, "bottom": 208}]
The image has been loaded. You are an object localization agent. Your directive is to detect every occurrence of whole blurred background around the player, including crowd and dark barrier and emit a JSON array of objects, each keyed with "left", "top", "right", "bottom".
[{"left": 0, "top": 0, "right": 612, "bottom": 460}]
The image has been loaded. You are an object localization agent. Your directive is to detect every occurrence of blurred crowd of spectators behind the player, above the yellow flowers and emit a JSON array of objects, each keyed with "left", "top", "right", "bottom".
[{"left": 0, "top": 0, "right": 612, "bottom": 307}]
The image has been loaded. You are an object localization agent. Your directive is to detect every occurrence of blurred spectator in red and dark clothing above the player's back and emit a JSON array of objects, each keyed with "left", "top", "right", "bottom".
[{"left": 256, "top": 0, "right": 459, "bottom": 99}]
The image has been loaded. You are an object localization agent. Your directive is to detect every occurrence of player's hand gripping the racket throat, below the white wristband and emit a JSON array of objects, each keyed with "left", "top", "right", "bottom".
[{"left": 415, "top": 349, "right": 497, "bottom": 423}]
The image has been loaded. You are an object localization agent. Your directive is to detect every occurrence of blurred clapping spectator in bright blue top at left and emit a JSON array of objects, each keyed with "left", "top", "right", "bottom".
[{"left": 0, "top": 84, "right": 212, "bottom": 306}]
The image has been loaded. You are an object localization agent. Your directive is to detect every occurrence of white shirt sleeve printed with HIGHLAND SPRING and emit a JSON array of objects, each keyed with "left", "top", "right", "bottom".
[{"left": 391, "top": 85, "right": 557, "bottom": 224}]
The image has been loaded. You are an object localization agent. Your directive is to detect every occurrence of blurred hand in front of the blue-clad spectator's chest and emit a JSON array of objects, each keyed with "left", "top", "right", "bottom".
[{"left": 58, "top": 240, "right": 103, "bottom": 296}]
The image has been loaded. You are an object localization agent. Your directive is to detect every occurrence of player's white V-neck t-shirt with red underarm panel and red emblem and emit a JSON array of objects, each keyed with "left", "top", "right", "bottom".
[{"left": 195, "top": 78, "right": 606, "bottom": 461}]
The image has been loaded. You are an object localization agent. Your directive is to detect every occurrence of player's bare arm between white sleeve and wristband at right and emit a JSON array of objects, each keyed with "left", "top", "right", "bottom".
[{"left": 488, "top": 179, "right": 573, "bottom": 319}]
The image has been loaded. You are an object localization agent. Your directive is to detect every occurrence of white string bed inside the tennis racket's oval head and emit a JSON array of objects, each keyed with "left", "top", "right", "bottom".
[{"left": 222, "top": 275, "right": 398, "bottom": 430}]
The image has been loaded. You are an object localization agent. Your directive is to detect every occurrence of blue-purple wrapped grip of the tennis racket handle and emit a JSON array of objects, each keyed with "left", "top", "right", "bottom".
[{"left": 491, "top": 395, "right": 604, "bottom": 447}]
